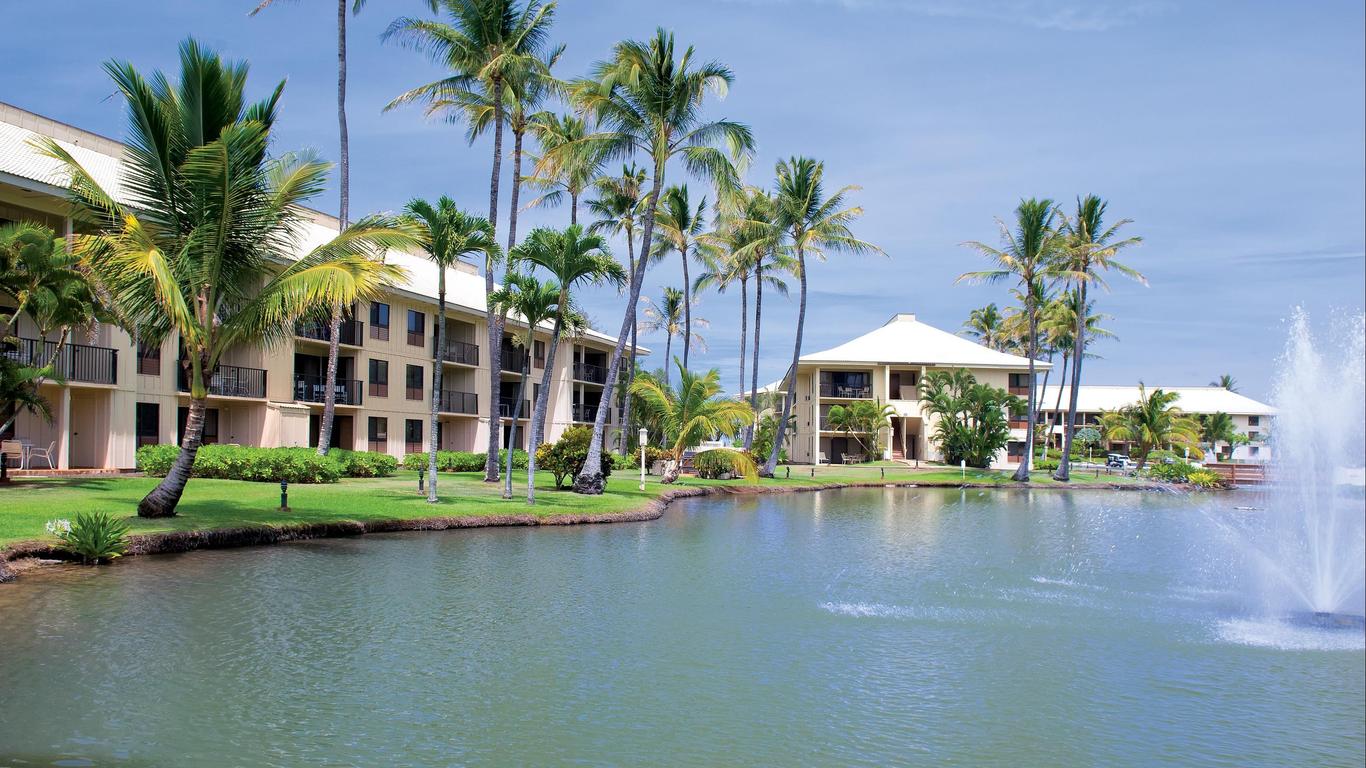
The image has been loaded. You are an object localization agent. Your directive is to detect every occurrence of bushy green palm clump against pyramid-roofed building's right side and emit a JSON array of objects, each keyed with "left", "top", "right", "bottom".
[{"left": 921, "top": 368, "right": 1029, "bottom": 469}]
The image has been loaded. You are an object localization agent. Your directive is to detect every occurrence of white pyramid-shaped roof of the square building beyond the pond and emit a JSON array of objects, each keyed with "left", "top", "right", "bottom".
[{"left": 802, "top": 313, "right": 1049, "bottom": 370}]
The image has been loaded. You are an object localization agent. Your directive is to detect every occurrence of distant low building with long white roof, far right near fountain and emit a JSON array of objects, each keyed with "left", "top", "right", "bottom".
[{"left": 1040, "top": 384, "right": 1276, "bottom": 462}]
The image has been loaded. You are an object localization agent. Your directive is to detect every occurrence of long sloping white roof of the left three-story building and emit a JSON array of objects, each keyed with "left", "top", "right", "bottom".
[{"left": 0, "top": 102, "right": 649, "bottom": 355}]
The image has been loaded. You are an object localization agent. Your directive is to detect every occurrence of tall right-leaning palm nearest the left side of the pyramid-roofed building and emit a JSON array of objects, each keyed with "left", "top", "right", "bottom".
[{"left": 759, "top": 157, "right": 882, "bottom": 477}]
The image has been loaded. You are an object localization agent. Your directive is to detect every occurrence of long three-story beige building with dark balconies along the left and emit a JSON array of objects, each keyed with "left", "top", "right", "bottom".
[{"left": 0, "top": 104, "right": 647, "bottom": 469}]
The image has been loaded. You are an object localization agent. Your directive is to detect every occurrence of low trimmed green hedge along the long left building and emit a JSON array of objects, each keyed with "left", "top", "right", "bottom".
[{"left": 138, "top": 445, "right": 398, "bottom": 484}]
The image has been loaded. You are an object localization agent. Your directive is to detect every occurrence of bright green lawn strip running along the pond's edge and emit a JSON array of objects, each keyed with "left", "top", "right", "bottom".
[{"left": 0, "top": 465, "right": 1134, "bottom": 547}]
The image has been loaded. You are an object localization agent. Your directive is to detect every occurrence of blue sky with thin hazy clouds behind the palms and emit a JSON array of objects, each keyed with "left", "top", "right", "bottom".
[{"left": 0, "top": 0, "right": 1366, "bottom": 399}]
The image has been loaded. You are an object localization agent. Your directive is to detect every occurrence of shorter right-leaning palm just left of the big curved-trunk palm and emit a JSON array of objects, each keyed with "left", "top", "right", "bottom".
[{"left": 512, "top": 224, "right": 626, "bottom": 504}]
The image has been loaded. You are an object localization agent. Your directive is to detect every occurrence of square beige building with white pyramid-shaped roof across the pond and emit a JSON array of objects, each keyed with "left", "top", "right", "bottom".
[{"left": 790, "top": 314, "right": 1048, "bottom": 466}]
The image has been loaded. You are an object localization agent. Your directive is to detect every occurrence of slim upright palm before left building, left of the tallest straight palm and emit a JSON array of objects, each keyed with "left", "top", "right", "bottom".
[{"left": 403, "top": 195, "right": 500, "bottom": 504}]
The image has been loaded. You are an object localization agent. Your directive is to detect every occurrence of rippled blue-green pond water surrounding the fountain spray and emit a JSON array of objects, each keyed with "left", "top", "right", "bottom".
[{"left": 0, "top": 489, "right": 1366, "bottom": 767}]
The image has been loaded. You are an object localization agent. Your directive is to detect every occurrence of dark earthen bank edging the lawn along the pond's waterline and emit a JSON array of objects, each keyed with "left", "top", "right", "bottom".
[{"left": 0, "top": 480, "right": 1165, "bottom": 584}]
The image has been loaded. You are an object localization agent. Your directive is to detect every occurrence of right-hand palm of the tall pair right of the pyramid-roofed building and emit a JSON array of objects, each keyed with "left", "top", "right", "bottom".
[{"left": 1053, "top": 194, "right": 1147, "bottom": 481}]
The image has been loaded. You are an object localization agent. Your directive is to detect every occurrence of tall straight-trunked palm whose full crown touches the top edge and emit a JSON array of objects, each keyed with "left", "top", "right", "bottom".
[{"left": 384, "top": 0, "right": 555, "bottom": 482}]
